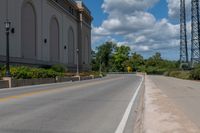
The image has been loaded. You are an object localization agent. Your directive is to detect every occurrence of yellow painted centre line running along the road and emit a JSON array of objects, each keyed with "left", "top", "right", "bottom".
[{"left": 0, "top": 77, "right": 122, "bottom": 102}]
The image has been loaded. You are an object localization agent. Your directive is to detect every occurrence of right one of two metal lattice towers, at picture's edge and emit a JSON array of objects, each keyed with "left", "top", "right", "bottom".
[{"left": 191, "top": 0, "right": 200, "bottom": 67}]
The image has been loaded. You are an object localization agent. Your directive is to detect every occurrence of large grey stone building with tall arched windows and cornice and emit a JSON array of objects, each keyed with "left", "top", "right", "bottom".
[{"left": 0, "top": 0, "right": 92, "bottom": 70}]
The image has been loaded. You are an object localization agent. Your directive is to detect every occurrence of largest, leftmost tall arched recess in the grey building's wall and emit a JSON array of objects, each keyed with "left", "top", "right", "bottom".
[{"left": 21, "top": 2, "right": 37, "bottom": 59}]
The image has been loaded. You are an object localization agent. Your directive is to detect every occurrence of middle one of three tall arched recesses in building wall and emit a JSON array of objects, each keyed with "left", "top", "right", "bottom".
[{"left": 50, "top": 17, "right": 60, "bottom": 62}]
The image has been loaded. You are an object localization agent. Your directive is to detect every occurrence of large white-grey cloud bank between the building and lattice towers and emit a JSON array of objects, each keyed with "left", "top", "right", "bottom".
[{"left": 92, "top": 0, "right": 183, "bottom": 55}]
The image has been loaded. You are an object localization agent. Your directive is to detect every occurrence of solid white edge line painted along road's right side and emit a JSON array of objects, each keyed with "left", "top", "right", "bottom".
[{"left": 115, "top": 77, "right": 144, "bottom": 133}]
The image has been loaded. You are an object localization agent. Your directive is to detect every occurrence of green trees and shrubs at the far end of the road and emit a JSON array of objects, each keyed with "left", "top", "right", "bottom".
[{"left": 92, "top": 42, "right": 177, "bottom": 74}]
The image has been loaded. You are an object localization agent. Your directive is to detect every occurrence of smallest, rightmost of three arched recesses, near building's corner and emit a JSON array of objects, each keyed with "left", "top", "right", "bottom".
[{"left": 68, "top": 27, "right": 75, "bottom": 65}]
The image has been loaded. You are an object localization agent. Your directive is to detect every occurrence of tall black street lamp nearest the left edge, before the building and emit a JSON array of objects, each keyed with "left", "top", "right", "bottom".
[{"left": 4, "top": 19, "right": 11, "bottom": 77}]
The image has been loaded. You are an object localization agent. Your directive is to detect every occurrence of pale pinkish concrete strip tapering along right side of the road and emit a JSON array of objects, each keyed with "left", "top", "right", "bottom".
[{"left": 143, "top": 76, "right": 200, "bottom": 133}]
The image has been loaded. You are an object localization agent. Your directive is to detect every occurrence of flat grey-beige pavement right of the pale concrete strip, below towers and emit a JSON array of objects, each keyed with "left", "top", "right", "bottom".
[{"left": 150, "top": 76, "right": 200, "bottom": 128}]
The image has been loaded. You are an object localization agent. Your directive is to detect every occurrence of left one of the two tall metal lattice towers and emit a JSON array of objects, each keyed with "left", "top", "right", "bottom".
[{"left": 180, "top": 0, "right": 188, "bottom": 67}]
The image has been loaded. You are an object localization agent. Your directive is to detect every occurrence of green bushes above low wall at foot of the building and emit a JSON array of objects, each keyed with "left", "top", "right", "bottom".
[{"left": 2, "top": 66, "right": 64, "bottom": 79}]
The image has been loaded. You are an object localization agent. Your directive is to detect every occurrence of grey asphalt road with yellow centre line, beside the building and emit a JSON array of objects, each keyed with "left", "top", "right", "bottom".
[{"left": 0, "top": 75, "right": 142, "bottom": 133}]
